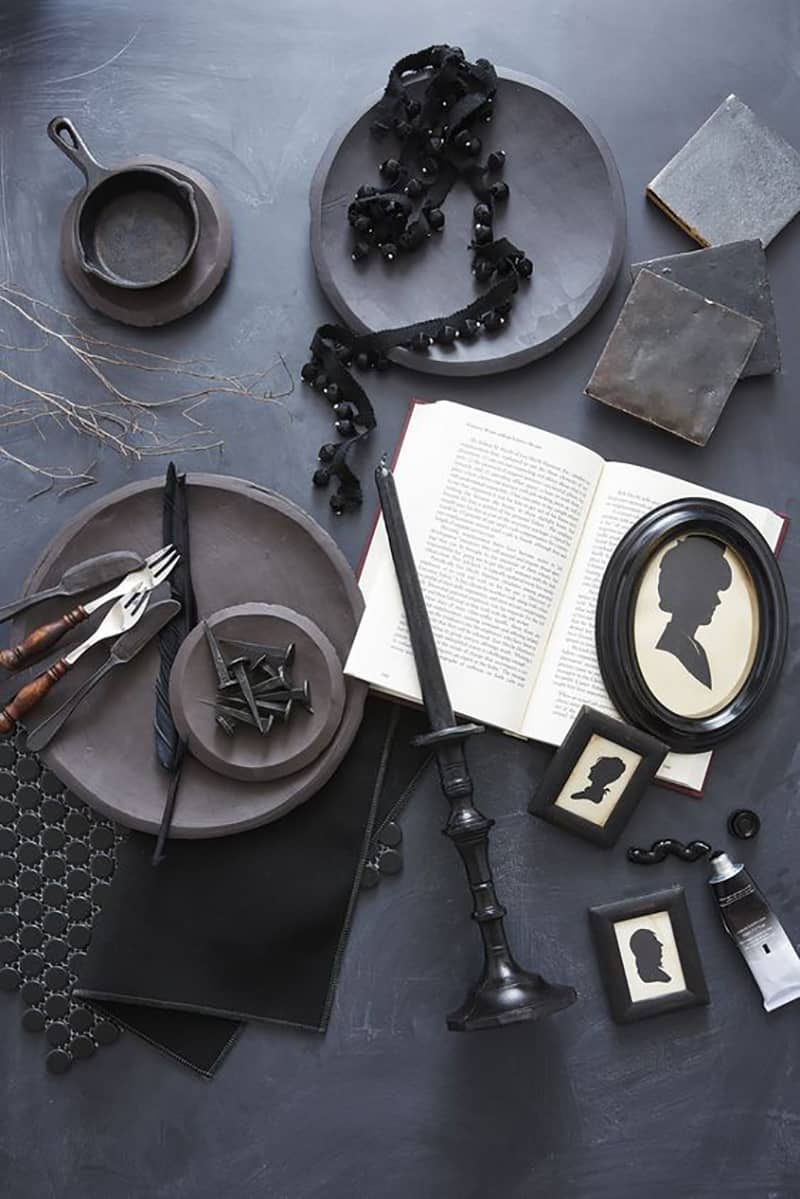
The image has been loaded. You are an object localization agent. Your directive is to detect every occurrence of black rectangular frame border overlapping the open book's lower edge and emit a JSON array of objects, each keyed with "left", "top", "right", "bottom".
[{"left": 528, "top": 705, "right": 668, "bottom": 848}]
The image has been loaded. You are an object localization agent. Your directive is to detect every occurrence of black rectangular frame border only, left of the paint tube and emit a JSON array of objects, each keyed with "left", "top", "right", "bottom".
[{"left": 589, "top": 886, "right": 709, "bottom": 1024}]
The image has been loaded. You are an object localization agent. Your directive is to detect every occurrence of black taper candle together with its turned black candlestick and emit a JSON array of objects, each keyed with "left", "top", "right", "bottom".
[{"left": 375, "top": 459, "right": 577, "bottom": 1031}]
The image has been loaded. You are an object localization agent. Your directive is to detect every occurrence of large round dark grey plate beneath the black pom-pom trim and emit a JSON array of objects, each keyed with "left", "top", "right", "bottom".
[{"left": 311, "top": 70, "right": 626, "bottom": 375}]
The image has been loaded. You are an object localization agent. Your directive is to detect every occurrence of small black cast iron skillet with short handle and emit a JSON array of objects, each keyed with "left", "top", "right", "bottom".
[{"left": 47, "top": 116, "right": 200, "bottom": 289}]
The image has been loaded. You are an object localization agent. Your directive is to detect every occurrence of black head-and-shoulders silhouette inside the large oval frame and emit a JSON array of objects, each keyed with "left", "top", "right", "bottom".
[{"left": 656, "top": 537, "right": 733, "bottom": 689}]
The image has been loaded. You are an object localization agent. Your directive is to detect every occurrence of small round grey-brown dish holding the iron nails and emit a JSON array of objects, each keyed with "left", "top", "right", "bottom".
[{"left": 169, "top": 603, "right": 344, "bottom": 783}]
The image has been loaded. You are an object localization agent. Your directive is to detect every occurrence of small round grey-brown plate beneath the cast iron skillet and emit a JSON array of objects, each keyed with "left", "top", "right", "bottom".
[{"left": 61, "top": 157, "right": 233, "bottom": 327}]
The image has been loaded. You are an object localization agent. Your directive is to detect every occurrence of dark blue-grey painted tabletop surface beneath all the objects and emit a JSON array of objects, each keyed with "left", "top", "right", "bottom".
[{"left": 0, "top": 0, "right": 800, "bottom": 1199}]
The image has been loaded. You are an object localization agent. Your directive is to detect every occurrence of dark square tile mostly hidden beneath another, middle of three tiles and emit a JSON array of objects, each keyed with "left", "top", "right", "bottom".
[{"left": 631, "top": 239, "right": 781, "bottom": 378}]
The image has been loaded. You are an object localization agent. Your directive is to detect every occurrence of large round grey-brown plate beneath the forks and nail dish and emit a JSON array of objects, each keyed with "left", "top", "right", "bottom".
[{"left": 14, "top": 474, "right": 367, "bottom": 837}]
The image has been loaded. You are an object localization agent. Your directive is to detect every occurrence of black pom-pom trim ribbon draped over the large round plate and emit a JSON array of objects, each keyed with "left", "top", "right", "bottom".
[{"left": 309, "top": 46, "right": 530, "bottom": 513}]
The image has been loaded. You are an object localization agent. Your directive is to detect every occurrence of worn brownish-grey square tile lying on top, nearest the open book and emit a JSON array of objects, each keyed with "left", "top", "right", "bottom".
[{"left": 585, "top": 270, "right": 762, "bottom": 446}]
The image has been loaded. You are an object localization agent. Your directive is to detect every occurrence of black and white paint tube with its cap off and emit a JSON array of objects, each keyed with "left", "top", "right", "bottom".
[{"left": 709, "top": 852, "right": 800, "bottom": 1012}]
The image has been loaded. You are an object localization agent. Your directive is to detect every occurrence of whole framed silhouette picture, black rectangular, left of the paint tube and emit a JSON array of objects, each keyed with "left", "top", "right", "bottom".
[{"left": 589, "top": 887, "right": 709, "bottom": 1024}]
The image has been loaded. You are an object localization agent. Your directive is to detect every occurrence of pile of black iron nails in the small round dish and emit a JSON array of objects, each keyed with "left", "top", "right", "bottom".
[{"left": 203, "top": 621, "right": 313, "bottom": 736}]
